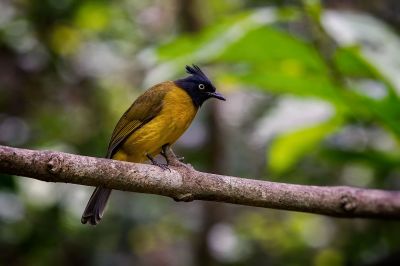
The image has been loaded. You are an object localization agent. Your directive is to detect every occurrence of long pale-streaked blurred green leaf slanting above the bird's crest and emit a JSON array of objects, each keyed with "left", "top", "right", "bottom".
[{"left": 151, "top": 8, "right": 298, "bottom": 78}]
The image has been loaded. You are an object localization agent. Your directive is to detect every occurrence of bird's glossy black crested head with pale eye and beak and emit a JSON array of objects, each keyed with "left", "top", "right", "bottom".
[{"left": 175, "top": 65, "right": 225, "bottom": 107}]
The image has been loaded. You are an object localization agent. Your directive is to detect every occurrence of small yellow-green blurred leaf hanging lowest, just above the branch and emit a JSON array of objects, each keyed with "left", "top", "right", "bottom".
[{"left": 268, "top": 117, "right": 342, "bottom": 175}]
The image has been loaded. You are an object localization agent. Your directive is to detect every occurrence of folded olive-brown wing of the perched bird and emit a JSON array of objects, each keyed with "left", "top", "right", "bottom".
[{"left": 106, "top": 83, "right": 168, "bottom": 158}]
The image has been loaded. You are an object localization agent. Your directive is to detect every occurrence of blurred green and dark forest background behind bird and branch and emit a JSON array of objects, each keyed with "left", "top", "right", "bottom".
[{"left": 0, "top": 0, "right": 400, "bottom": 266}]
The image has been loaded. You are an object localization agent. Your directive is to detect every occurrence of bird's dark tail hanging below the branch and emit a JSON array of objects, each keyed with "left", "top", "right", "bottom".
[{"left": 81, "top": 187, "right": 111, "bottom": 225}]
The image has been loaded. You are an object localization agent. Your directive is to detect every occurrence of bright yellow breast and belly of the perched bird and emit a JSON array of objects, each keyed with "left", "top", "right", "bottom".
[{"left": 113, "top": 83, "right": 197, "bottom": 162}]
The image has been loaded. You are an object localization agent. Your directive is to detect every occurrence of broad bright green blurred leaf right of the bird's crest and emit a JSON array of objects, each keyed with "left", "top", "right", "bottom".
[{"left": 212, "top": 26, "right": 343, "bottom": 105}]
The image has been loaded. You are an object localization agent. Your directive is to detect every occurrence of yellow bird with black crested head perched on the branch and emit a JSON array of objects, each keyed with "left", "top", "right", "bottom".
[{"left": 81, "top": 64, "right": 226, "bottom": 225}]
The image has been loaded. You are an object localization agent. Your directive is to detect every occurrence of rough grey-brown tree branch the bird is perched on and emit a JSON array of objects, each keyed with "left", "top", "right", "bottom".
[{"left": 0, "top": 146, "right": 400, "bottom": 219}]
